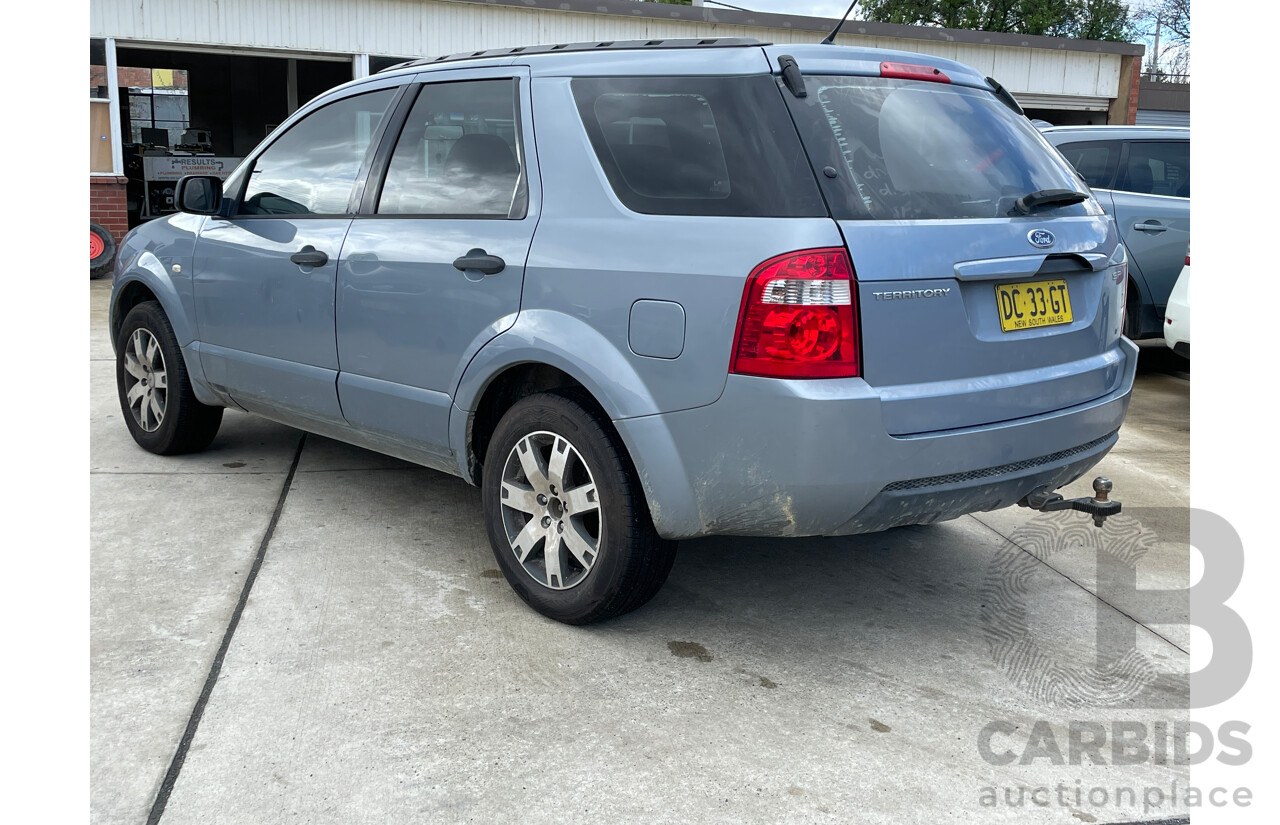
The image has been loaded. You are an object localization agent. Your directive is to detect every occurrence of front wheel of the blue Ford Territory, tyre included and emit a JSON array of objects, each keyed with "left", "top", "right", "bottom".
[{"left": 115, "top": 301, "right": 223, "bottom": 455}]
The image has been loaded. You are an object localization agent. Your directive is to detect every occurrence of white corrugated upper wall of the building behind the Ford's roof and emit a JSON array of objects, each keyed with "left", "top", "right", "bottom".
[{"left": 90, "top": 0, "right": 1120, "bottom": 105}]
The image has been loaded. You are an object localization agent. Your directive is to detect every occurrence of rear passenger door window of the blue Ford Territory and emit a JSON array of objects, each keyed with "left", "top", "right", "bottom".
[{"left": 378, "top": 79, "right": 527, "bottom": 219}]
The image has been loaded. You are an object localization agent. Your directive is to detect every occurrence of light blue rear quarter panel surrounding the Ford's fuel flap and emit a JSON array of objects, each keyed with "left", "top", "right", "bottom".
[{"left": 494, "top": 78, "right": 844, "bottom": 418}]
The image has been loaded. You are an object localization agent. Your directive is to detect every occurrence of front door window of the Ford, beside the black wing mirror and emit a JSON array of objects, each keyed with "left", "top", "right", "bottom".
[{"left": 239, "top": 88, "right": 396, "bottom": 215}]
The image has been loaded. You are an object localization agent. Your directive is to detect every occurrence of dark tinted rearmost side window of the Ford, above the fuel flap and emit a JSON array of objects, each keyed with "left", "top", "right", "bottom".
[{"left": 573, "top": 75, "right": 827, "bottom": 217}]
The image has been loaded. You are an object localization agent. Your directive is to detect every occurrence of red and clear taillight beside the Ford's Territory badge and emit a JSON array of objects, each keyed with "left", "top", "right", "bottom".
[{"left": 730, "top": 248, "right": 859, "bottom": 379}]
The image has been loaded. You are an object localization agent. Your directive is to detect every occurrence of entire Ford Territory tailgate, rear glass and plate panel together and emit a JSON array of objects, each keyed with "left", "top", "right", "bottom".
[{"left": 786, "top": 74, "right": 1124, "bottom": 435}]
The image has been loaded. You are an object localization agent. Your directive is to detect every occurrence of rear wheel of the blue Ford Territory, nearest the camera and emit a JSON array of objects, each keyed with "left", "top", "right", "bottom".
[{"left": 481, "top": 394, "right": 676, "bottom": 624}]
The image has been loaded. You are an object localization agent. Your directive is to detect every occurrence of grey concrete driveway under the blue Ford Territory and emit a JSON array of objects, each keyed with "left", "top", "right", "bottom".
[{"left": 90, "top": 283, "right": 1189, "bottom": 825}]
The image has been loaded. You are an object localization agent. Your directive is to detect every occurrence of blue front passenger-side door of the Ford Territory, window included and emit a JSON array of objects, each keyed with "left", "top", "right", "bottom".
[{"left": 193, "top": 87, "right": 398, "bottom": 422}]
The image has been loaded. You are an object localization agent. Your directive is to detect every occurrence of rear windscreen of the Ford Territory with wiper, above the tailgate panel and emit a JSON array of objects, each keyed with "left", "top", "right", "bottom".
[{"left": 786, "top": 75, "right": 1098, "bottom": 220}]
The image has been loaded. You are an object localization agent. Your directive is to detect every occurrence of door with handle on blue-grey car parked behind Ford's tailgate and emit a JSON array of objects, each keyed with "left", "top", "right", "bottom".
[{"left": 1111, "top": 141, "right": 1190, "bottom": 310}]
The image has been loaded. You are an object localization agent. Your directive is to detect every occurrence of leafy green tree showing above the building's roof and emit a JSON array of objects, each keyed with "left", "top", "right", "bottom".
[{"left": 859, "top": 0, "right": 1136, "bottom": 41}]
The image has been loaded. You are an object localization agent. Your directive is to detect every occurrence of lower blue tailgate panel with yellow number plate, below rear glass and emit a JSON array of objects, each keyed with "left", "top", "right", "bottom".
[{"left": 841, "top": 217, "right": 1124, "bottom": 435}]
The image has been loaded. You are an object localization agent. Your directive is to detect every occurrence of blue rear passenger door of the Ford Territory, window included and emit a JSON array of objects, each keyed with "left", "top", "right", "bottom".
[{"left": 337, "top": 67, "right": 540, "bottom": 454}]
